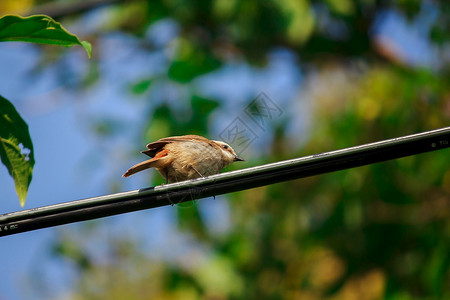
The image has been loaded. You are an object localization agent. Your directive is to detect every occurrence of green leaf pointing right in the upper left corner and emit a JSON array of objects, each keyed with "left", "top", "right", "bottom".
[{"left": 0, "top": 15, "right": 92, "bottom": 58}]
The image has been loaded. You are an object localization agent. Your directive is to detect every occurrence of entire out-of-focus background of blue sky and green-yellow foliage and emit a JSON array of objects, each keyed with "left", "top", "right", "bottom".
[{"left": 0, "top": 0, "right": 450, "bottom": 300}]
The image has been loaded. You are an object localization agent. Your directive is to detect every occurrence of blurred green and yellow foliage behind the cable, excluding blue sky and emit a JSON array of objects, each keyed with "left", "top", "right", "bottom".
[{"left": 20, "top": 0, "right": 450, "bottom": 299}]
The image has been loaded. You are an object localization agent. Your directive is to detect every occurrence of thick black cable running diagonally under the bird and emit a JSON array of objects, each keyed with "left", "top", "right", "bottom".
[{"left": 0, "top": 127, "right": 450, "bottom": 236}]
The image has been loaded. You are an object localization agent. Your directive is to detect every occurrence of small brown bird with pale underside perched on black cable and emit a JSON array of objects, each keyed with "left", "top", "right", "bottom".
[{"left": 122, "top": 135, "right": 243, "bottom": 183}]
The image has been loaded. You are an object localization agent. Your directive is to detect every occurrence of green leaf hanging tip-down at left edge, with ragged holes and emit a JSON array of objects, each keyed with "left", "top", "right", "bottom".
[{"left": 0, "top": 96, "right": 34, "bottom": 206}]
